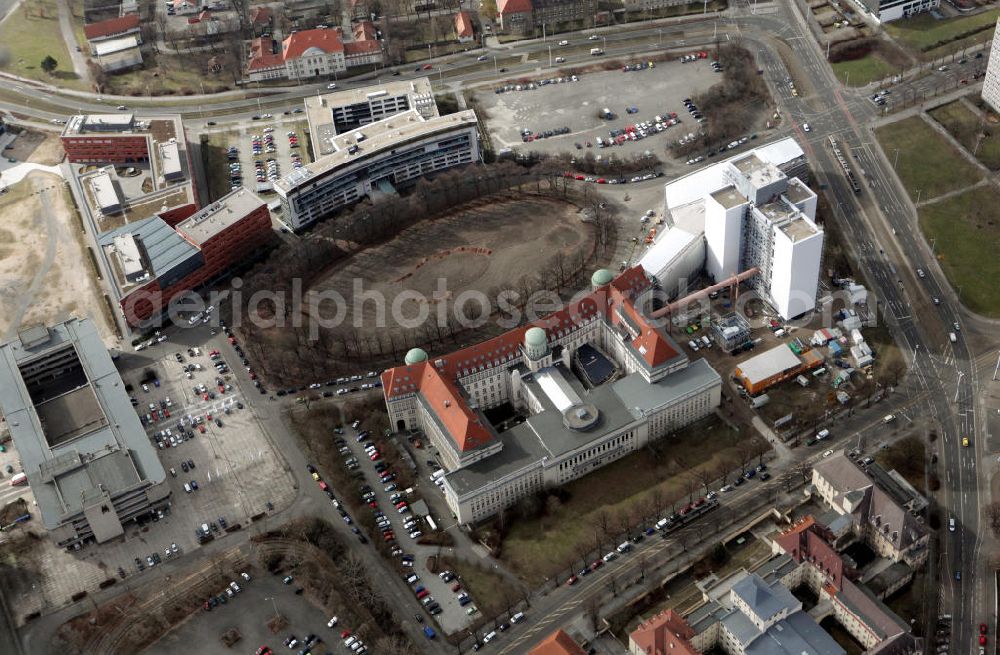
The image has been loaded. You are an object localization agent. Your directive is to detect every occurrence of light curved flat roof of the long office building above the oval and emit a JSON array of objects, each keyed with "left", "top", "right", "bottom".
[{"left": 275, "top": 109, "right": 476, "bottom": 193}]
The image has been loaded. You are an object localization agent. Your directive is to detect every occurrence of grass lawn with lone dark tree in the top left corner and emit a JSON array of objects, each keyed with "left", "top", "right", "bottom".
[{"left": 0, "top": 0, "right": 87, "bottom": 89}]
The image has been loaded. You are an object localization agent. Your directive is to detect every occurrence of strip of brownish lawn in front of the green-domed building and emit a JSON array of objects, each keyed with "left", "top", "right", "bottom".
[{"left": 501, "top": 420, "right": 745, "bottom": 584}]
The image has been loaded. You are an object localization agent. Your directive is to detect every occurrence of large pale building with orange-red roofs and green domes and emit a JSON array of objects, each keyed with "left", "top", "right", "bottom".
[{"left": 382, "top": 266, "right": 722, "bottom": 523}]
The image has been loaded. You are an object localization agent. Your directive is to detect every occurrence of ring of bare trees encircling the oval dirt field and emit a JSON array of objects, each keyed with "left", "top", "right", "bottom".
[{"left": 232, "top": 161, "right": 617, "bottom": 384}]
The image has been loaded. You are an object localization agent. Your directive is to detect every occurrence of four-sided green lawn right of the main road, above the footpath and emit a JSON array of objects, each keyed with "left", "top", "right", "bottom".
[{"left": 876, "top": 116, "right": 982, "bottom": 200}]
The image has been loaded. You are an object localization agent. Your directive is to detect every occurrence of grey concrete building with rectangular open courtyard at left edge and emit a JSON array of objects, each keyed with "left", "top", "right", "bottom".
[{"left": 0, "top": 319, "right": 170, "bottom": 548}]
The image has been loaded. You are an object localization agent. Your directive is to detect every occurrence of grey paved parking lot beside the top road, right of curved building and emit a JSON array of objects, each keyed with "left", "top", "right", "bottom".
[{"left": 477, "top": 60, "right": 721, "bottom": 157}]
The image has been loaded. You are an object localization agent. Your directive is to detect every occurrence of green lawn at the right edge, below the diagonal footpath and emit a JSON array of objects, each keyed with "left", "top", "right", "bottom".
[{"left": 920, "top": 186, "right": 1000, "bottom": 317}]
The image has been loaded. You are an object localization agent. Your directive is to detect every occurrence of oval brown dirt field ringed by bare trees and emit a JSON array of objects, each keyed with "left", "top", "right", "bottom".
[{"left": 307, "top": 197, "right": 595, "bottom": 327}]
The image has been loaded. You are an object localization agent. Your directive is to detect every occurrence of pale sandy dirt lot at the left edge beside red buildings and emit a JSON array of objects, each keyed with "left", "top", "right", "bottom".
[{"left": 0, "top": 172, "right": 112, "bottom": 335}]
